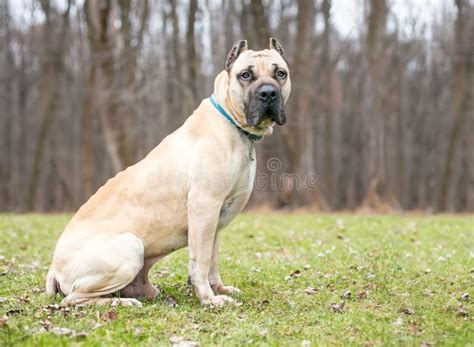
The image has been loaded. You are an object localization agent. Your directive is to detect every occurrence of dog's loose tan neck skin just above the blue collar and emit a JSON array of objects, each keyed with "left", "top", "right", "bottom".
[{"left": 214, "top": 71, "right": 274, "bottom": 136}]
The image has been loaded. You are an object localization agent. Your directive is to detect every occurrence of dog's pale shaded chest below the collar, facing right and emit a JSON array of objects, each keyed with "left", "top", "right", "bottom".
[{"left": 218, "top": 146, "right": 257, "bottom": 229}]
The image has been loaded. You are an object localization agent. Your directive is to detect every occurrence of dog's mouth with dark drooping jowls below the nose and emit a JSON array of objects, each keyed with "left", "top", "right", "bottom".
[{"left": 244, "top": 92, "right": 286, "bottom": 129}]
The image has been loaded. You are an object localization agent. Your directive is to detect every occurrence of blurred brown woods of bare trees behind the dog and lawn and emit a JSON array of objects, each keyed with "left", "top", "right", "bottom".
[{"left": 0, "top": 0, "right": 474, "bottom": 211}]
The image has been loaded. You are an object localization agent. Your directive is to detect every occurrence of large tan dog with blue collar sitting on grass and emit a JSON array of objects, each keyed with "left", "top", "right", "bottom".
[{"left": 46, "top": 38, "right": 291, "bottom": 306}]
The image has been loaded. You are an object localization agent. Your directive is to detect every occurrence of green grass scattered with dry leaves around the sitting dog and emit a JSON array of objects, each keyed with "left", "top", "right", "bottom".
[{"left": 0, "top": 215, "right": 474, "bottom": 346}]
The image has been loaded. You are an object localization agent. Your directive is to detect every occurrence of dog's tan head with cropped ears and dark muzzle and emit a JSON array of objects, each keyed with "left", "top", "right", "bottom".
[{"left": 215, "top": 38, "right": 291, "bottom": 135}]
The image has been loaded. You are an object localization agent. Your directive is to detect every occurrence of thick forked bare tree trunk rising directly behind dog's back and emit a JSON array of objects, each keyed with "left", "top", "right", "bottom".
[{"left": 84, "top": 0, "right": 148, "bottom": 172}]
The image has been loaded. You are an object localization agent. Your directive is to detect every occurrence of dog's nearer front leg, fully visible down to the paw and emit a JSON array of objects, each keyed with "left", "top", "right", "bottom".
[{"left": 188, "top": 192, "right": 234, "bottom": 306}]
